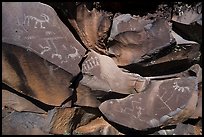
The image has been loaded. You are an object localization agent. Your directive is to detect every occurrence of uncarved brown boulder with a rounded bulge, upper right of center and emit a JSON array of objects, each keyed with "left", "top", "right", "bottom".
[{"left": 108, "top": 14, "right": 175, "bottom": 66}]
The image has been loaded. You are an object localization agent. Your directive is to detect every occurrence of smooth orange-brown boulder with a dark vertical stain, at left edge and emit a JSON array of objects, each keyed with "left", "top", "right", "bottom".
[{"left": 2, "top": 43, "right": 73, "bottom": 106}]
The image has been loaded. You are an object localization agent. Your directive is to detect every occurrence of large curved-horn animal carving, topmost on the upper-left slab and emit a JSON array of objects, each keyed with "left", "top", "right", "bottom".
[{"left": 23, "top": 13, "right": 50, "bottom": 29}]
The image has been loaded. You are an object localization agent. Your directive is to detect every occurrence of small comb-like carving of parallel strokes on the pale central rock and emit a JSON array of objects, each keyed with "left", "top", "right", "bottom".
[{"left": 82, "top": 57, "right": 100, "bottom": 72}]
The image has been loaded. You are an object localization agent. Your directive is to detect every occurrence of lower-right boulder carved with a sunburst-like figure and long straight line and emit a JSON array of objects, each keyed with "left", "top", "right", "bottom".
[{"left": 99, "top": 77, "right": 198, "bottom": 130}]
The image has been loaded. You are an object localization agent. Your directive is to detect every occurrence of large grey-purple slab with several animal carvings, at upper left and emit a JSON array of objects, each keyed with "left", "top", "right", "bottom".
[{"left": 2, "top": 2, "right": 86, "bottom": 76}]
